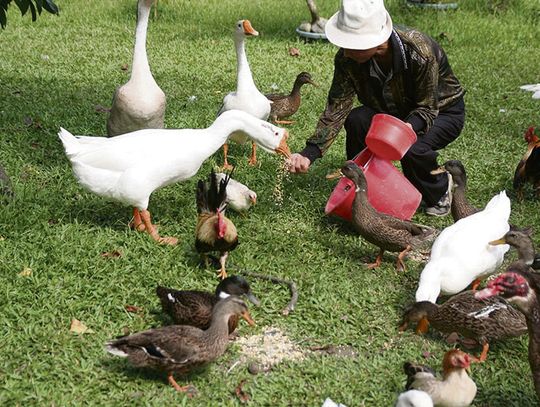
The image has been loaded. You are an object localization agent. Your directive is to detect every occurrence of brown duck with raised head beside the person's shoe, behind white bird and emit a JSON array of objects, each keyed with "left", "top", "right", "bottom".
[{"left": 431, "top": 160, "right": 479, "bottom": 222}]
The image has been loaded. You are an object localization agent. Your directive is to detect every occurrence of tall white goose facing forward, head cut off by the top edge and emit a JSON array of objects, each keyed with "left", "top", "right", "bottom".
[{"left": 107, "top": 0, "right": 166, "bottom": 137}]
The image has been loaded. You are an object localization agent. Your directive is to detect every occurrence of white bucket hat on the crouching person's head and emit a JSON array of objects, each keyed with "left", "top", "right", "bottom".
[{"left": 324, "top": 0, "right": 392, "bottom": 50}]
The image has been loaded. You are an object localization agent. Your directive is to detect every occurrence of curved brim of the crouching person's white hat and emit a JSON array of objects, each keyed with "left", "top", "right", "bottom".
[{"left": 324, "top": 10, "right": 392, "bottom": 50}]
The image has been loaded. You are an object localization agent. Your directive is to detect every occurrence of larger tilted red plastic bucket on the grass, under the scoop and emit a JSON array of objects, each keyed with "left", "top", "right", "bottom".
[{"left": 324, "top": 148, "right": 422, "bottom": 221}]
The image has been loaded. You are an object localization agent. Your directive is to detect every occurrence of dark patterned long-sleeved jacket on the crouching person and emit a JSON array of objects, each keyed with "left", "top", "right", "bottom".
[{"left": 301, "top": 28, "right": 464, "bottom": 162}]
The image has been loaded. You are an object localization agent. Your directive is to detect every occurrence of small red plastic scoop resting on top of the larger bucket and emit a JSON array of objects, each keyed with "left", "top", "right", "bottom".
[{"left": 366, "top": 113, "right": 416, "bottom": 161}]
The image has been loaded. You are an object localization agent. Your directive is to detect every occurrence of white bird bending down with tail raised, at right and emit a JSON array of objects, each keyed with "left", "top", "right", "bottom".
[{"left": 416, "top": 191, "right": 510, "bottom": 303}]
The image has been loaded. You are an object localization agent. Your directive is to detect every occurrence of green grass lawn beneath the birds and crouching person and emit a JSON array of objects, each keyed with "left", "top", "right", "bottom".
[{"left": 0, "top": 0, "right": 540, "bottom": 407}]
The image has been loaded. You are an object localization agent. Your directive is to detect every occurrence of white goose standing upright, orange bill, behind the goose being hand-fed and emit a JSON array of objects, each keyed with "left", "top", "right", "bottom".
[{"left": 218, "top": 20, "right": 270, "bottom": 170}]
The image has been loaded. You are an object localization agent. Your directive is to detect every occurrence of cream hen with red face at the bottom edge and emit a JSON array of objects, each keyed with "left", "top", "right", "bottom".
[{"left": 403, "top": 349, "right": 476, "bottom": 407}]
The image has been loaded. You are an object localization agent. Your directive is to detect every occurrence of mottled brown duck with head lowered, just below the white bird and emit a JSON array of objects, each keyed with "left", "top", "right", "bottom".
[{"left": 399, "top": 291, "right": 527, "bottom": 362}]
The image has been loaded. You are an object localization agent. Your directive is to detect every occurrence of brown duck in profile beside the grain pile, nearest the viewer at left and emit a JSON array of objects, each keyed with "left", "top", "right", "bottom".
[{"left": 105, "top": 296, "right": 255, "bottom": 391}]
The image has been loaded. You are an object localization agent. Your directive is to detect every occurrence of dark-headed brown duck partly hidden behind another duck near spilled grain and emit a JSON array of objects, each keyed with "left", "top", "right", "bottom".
[{"left": 156, "top": 276, "right": 259, "bottom": 334}]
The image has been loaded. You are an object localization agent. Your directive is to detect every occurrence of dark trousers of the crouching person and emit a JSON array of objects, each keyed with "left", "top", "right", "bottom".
[{"left": 345, "top": 99, "right": 465, "bottom": 206}]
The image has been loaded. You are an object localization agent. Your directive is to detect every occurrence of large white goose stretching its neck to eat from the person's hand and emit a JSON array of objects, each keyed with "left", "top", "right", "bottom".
[{"left": 58, "top": 110, "right": 290, "bottom": 244}]
